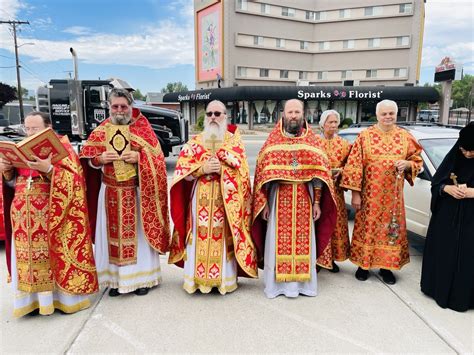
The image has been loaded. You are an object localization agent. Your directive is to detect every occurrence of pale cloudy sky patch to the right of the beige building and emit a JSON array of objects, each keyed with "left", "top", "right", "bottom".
[{"left": 422, "top": 0, "right": 474, "bottom": 72}]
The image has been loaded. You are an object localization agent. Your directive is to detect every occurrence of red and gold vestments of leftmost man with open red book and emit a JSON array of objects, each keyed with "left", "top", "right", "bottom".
[{"left": 4, "top": 136, "right": 98, "bottom": 294}]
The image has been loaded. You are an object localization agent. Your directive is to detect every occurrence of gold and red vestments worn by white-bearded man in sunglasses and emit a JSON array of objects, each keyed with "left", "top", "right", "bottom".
[{"left": 169, "top": 125, "right": 257, "bottom": 286}]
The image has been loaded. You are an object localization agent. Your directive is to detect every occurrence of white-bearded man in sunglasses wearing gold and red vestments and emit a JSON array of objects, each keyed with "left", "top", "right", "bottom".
[{"left": 169, "top": 101, "right": 257, "bottom": 294}]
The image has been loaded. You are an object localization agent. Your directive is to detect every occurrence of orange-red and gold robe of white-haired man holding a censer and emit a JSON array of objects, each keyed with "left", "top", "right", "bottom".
[{"left": 340, "top": 125, "right": 423, "bottom": 270}]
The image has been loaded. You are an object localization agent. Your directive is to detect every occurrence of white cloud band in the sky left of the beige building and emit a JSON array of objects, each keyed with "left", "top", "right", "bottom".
[{"left": 0, "top": 0, "right": 194, "bottom": 69}]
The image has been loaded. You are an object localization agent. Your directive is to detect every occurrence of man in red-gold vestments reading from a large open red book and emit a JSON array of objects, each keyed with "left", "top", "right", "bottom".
[{"left": 0, "top": 112, "right": 98, "bottom": 317}]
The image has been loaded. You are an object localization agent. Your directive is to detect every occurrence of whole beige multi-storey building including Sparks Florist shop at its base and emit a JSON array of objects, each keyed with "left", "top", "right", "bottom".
[{"left": 177, "top": 0, "right": 430, "bottom": 125}]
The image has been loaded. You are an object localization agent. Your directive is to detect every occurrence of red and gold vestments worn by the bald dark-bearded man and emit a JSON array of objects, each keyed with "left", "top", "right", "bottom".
[{"left": 252, "top": 120, "right": 336, "bottom": 272}]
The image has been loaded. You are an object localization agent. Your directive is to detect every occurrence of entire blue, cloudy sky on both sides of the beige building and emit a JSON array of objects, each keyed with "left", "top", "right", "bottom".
[{"left": 0, "top": 0, "right": 474, "bottom": 93}]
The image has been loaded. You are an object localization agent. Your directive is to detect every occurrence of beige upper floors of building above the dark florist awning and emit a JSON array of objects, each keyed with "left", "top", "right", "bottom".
[{"left": 194, "top": 0, "right": 425, "bottom": 89}]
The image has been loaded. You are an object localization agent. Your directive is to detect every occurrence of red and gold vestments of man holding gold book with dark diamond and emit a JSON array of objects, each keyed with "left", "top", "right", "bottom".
[{"left": 79, "top": 108, "right": 170, "bottom": 258}]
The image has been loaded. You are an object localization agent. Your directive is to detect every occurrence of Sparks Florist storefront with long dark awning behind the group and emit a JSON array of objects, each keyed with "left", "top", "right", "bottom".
[{"left": 163, "top": 86, "right": 439, "bottom": 128}]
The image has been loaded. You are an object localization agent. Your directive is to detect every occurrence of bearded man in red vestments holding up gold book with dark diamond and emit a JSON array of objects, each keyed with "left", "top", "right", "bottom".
[{"left": 79, "top": 89, "right": 170, "bottom": 297}]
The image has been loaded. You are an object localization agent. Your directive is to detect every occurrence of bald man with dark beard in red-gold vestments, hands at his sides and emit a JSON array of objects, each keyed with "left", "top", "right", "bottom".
[{"left": 252, "top": 99, "right": 336, "bottom": 298}]
